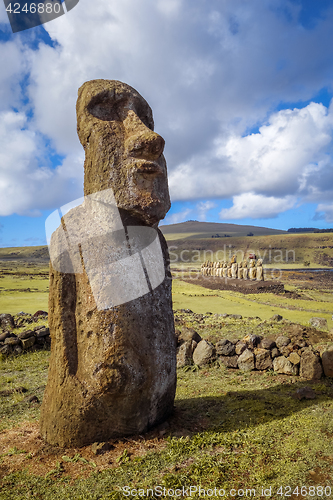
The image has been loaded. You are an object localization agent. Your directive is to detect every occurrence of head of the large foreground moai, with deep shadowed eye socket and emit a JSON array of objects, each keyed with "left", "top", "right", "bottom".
[{"left": 76, "top": 80, "right": 170, "bottom": 226}]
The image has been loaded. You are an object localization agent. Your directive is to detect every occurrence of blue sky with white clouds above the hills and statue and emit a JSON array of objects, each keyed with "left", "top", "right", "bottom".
[{"left": 0, "top": 0, "right": 333, "bottom": 247}]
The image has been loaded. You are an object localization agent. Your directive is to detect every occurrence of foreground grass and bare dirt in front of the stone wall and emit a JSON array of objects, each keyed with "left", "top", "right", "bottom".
[{"left": 0, "top": 336, "right": 333, "bottom": 500}]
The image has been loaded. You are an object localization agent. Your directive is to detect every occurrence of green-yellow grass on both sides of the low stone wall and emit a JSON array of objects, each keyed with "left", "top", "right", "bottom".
[{"left": 0, "top": 241, "right": 333, "bottom": 500}]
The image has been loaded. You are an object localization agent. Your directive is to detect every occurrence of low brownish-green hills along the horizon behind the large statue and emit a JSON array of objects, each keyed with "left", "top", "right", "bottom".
[{"left": 0, "top": 221, "right": 333, "bottom": 268}]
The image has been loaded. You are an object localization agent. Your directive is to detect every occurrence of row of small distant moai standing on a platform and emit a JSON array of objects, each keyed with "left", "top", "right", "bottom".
[{"left": 201, "top": 255, "right": 264, "bottom": 281}]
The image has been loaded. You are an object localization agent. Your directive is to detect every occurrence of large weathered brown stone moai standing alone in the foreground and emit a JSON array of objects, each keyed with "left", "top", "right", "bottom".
[{"left": 40, "top": 80, "right": 176, "bottom": 447}]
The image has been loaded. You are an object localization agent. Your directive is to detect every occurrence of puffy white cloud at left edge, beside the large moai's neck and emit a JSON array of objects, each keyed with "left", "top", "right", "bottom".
[{"left": 0, "top": 111, "right": 83, "bottom": 216}]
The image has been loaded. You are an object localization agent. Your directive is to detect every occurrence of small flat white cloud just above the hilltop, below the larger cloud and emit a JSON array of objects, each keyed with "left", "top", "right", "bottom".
[{"left": 219, "top": 193, "right": 297, "bottom": 220}]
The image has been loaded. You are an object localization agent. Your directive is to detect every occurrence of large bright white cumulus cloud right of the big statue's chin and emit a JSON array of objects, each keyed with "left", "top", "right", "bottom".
[{"left": 170, "top": 103, "right": 333, "bottom": 205}]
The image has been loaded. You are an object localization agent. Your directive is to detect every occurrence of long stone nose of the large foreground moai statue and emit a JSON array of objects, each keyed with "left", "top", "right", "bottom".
[{"left": 123, "top": 111, "right": 165, "bottom": 160}]
